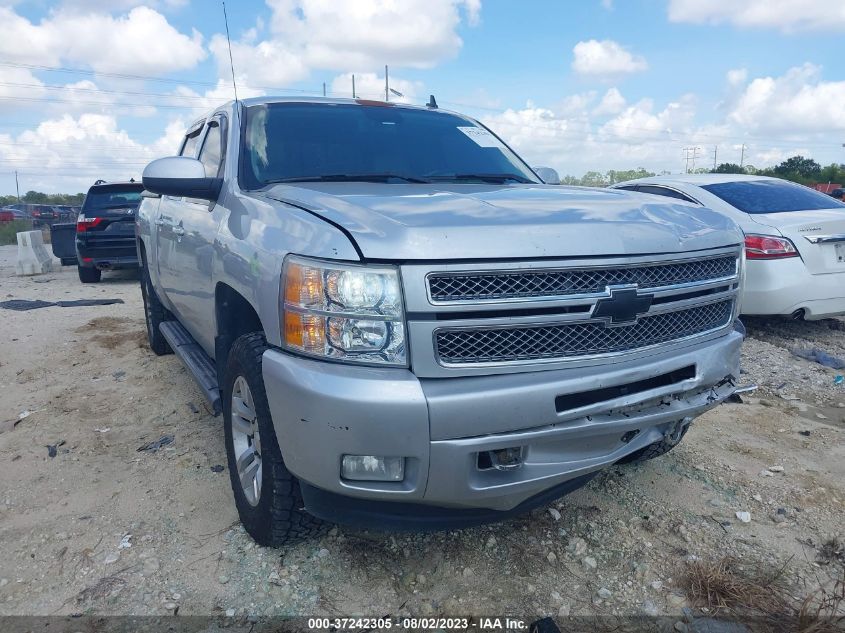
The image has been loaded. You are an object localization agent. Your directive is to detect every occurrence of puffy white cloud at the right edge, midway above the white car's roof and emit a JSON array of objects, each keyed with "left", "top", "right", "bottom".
[{"left": 728, "top": 64, "right": 845, "bottom": 134}]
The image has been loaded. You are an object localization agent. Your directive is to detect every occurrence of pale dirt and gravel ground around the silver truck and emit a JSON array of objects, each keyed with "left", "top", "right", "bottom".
[{"left": 0, "top": 247, "right": 845, "bottom": 630}]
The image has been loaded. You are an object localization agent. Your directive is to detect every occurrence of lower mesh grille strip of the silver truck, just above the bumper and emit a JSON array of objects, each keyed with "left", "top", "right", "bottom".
[{"left": 435, "top": 299, "right": 733, "bottom": 365}]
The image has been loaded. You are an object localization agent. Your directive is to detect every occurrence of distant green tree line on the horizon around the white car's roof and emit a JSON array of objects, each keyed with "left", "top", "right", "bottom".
[{"left": 560, "top": 156, "right": 845, "bottom": 187}]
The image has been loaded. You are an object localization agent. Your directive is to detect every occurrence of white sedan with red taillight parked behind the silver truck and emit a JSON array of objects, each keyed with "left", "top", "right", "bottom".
[{"left": 612, "top": 174, "right": 845, "bottom": 320}]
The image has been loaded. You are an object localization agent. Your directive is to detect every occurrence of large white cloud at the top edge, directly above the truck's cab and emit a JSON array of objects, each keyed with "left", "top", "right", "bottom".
[{"left": 210, "top": 0, "right": 481, "bottom": 85}]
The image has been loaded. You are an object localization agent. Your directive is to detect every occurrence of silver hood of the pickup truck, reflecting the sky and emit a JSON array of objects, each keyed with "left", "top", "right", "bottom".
[{"left": 260, "top": 183, "right": 742, "bottom": 261}]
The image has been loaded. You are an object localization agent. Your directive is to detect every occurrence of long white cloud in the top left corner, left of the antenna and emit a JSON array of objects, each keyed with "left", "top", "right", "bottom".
[{"left": 0, "top": 6, "right": 206, "bottom": 74}]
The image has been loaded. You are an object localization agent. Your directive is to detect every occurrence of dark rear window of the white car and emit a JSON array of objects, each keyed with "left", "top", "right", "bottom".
[{"left": 702, "top": 180, "right": 845, "bottom": 213}]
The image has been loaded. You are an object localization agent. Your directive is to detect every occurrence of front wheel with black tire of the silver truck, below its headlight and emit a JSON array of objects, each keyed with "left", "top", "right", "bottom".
[{"left": 222, "top": 332, "right": 328, "bottom": 547}]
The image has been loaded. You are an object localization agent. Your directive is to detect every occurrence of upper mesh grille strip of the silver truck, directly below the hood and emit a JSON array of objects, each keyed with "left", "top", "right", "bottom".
[{"left": 428, "top": 255, "right": 736, "bottom": 303}]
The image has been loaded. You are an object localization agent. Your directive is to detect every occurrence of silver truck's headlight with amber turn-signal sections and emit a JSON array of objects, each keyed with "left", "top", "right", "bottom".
[{"left": 282, "top": 256, "right": 407, "bottom": 366}]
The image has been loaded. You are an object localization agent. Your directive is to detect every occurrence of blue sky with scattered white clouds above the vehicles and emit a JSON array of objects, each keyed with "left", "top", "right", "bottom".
[{"left": 0, "top": 0, "right": 845, "bottom": 194}]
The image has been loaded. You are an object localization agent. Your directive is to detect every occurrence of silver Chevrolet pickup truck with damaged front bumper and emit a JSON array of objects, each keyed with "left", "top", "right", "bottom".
[{"left": 137, "top": 98, "right": 744, "bottom": 545}]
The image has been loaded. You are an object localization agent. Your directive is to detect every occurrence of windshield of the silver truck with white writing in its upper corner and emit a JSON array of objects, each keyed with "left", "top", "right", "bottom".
[{"left": 241, "top": 103, "right": 538, "bottom": 189}]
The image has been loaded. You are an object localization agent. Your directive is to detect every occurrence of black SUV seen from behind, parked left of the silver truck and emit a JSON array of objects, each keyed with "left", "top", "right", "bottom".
[{"left": 76, "top": 181, "right": 144, "bottom": 284}]
